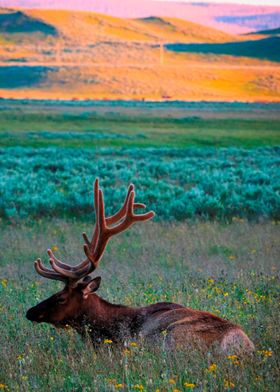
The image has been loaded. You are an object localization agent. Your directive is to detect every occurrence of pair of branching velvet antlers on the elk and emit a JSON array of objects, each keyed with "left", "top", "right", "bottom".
[{"left": 35, "top": 178, "right": 155, "bottom": 284}]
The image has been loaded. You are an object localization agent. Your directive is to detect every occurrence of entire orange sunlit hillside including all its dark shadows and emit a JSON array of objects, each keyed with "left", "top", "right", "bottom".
[{"left": 0, "top": 9, "right": 280, "bottom": 101}]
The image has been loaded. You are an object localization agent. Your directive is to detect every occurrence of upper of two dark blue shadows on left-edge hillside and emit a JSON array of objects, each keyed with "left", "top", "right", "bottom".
[{"left": 0, "top": 11, "right": 58, "bottom": 35}]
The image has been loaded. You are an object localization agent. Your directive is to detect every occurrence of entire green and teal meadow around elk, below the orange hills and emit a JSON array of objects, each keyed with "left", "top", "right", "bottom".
[{"left": 0, "top": 100, "right": 280, "bottom": 392}]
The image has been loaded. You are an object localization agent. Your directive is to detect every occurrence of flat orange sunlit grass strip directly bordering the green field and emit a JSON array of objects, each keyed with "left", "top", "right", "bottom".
[{"left": 0, "top": 62, "right": 280, "bottom": 102}]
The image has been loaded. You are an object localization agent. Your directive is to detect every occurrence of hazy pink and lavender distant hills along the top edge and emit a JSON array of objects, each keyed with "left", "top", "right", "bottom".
[{"left": 0, "top": 0, "right": 280, "bottom": 34}]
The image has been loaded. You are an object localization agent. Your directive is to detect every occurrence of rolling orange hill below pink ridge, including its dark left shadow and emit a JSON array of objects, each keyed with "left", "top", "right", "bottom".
[{"left": 0, "top": 9, "right": 237, "bottom": 44}]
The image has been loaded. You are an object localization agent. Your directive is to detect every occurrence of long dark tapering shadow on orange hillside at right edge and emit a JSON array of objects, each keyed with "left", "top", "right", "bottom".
[{"left": 165, "top": 37, "right": 280, "bottom": 62}]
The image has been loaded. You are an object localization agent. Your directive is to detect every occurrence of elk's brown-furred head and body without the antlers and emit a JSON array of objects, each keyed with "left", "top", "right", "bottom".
[{"left": 27, "top": 284, "right": 254, "bottom": 354}]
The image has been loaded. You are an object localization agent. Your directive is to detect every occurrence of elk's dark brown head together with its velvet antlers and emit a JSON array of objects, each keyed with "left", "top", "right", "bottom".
[{"left": 26, "top": 179, "right": 155, "bottom": 327}]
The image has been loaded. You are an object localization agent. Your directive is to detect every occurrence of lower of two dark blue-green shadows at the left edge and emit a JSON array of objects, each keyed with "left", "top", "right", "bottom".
[{"left": 0, "top": 66, "right": 56, "bottom": 89}]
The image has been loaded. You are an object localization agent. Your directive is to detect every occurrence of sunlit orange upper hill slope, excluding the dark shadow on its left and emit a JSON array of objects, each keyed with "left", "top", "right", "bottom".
[{"left": 22, "top": 10, "right": 238, "bottom": 43}]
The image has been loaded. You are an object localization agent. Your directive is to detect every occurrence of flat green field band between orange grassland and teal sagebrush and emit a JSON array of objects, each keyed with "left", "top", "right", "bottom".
[{"left": 0, "top": 100, "right": 280, "bottom": 148}]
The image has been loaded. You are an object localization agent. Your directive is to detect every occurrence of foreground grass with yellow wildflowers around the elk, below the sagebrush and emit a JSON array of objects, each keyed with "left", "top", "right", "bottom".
[{"left": 0, "top": 218, "right": 280, "bottom": 392}]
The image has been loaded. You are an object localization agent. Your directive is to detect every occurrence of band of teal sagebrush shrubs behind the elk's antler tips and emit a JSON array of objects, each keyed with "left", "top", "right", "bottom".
[{"left": 0, "top": 147, "right": 280, "bottom": 220}]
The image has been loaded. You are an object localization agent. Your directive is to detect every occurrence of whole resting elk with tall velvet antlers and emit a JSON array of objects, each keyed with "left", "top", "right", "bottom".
[{"left": 26, "top": 179, "right": 254, "bottom": 354}]
